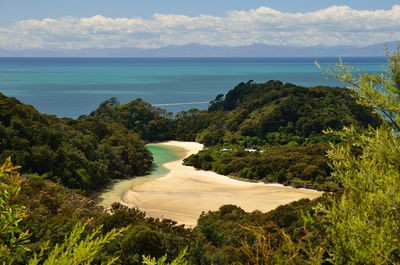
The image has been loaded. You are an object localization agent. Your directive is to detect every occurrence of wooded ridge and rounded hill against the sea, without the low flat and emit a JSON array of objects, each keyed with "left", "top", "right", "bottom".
[{"left": 88, "top": 80, "right": 381, "bottom": 147}]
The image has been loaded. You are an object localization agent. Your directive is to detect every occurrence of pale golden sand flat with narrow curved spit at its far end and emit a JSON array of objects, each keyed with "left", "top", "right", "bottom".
[{"left": 123, "top": 141, "right": 322, "bottom": 226}]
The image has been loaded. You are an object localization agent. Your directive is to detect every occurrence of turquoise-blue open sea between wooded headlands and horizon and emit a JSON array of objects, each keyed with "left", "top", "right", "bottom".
[{"left": 0, "top": 57, "right": 387, "bottom": 118}]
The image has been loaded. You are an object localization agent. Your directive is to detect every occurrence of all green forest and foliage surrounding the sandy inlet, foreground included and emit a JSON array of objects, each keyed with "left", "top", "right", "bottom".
[{"left": 0, "top": 46, "right": 400, "bottom": 264}]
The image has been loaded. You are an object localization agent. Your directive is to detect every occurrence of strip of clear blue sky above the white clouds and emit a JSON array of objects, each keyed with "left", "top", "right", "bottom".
[{"left": 0, "top": 0, "right": 400, "bottom": 26}]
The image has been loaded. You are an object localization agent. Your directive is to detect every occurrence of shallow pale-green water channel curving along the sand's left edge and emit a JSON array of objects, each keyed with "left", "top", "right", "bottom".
[{"left": 97, "top": 144, "right": 185, "bottom": 208}]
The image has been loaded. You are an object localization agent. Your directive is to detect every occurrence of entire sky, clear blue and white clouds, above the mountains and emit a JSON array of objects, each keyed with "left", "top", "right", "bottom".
[{"left": 0, "top": 0, "right": 400, "bottom": 50}]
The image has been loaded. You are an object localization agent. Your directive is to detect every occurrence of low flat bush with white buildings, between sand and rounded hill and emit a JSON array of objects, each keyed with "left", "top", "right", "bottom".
[{"left": 185, "top": 144, "right": 338, "bottom": 191}]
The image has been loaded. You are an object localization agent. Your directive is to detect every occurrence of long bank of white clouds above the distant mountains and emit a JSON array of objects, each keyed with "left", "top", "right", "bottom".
[{"left": 0, "top": 5, "right": 400, "bottom": 49}]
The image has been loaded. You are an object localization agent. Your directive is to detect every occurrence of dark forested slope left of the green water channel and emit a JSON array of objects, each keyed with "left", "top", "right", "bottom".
[{"left": 0, "top": 94, "right": 152, "bottom": 191}]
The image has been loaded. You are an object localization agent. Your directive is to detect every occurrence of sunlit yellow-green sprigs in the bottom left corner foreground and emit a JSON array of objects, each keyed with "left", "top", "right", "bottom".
[{"left": 0, "top": 158, "right": 127, "bottom": 265}]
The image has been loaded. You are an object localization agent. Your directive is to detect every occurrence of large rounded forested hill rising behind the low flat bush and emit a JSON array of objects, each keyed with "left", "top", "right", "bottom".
[{"left": 205, "top": 81, "right": 380, "bottom": 143}]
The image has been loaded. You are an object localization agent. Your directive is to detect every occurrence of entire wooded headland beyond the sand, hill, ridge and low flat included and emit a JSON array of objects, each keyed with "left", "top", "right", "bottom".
[{"left": 85, "top": 81, "right": 382, "bottom": 191}]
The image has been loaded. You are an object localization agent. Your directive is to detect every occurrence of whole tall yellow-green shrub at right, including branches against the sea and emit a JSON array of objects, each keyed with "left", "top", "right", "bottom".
[{"left": 317, "top": 46, "right": 400, "bottom": 264}]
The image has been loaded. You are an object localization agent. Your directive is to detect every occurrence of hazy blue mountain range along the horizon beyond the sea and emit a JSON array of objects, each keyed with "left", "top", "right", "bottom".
[{"left": 0, "top": 41, "right": 399, "bottom": 57}]
